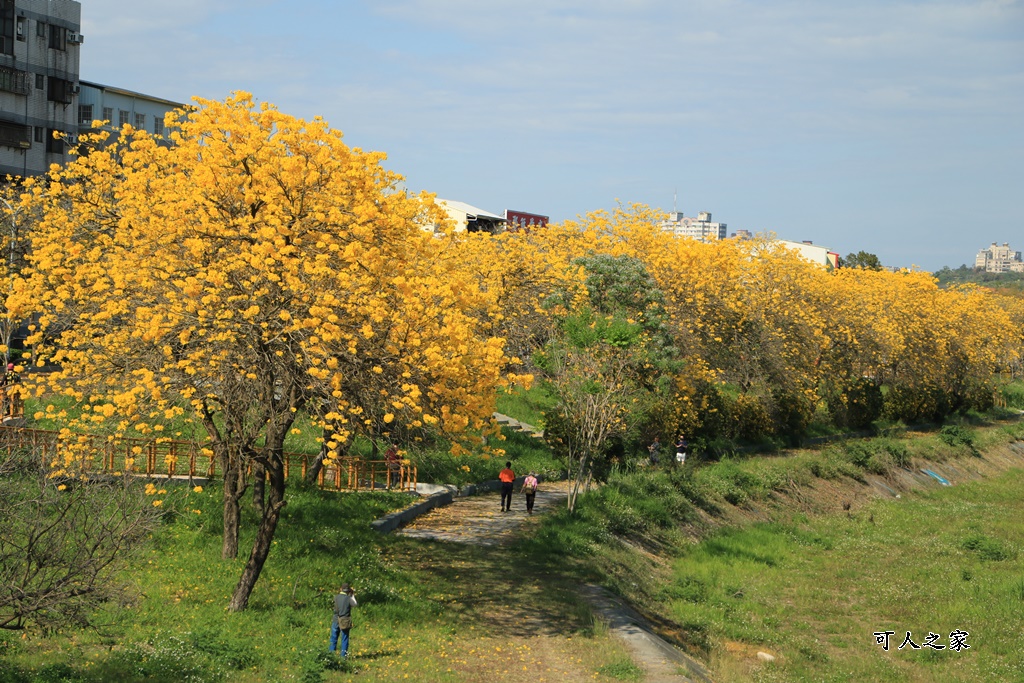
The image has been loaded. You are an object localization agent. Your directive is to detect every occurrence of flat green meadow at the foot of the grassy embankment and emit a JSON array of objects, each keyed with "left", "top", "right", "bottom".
[{"left": 668, "top": 471, "right": 1024, "bottom": 681}]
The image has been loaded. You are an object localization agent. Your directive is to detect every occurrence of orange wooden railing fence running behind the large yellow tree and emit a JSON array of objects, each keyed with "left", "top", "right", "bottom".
[{"left": 0, "top": 426, "right": 417, "bottom": 490}]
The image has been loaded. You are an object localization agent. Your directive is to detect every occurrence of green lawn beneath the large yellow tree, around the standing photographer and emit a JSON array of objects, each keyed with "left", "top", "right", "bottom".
[{"left": 0, "top": 485, "right": 415, "bottom": 681}]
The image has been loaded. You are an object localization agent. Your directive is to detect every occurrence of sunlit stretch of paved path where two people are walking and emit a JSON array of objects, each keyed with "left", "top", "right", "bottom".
[{"left": 398, "top": 481, "right": 568, "bottom": 546}]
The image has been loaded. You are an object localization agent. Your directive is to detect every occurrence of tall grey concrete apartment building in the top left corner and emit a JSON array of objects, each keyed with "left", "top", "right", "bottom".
[{"left": 0, "top": 0, "right": 83, "bottom": 176}]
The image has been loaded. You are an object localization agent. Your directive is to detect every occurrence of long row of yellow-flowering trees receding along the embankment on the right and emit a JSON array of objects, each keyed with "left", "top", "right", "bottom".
[{"left": 473, "top": 205, "right": 1024, "bottom": 446}]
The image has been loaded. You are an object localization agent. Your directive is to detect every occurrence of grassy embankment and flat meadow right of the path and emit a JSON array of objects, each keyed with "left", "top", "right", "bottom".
[{"left": 516, "top": 413, "right": 1024, "bottom": 681}]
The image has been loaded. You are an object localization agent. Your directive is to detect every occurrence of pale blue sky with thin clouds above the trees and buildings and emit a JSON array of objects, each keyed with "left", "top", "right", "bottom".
[{"left": 81, "top": 0, "right": 1024, "bottom": 270}]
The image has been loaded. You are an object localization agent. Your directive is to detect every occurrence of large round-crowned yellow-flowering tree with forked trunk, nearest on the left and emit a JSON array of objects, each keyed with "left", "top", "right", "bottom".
[{"left": 23, "top": 93, "right": 505, "bottom": 610}]
